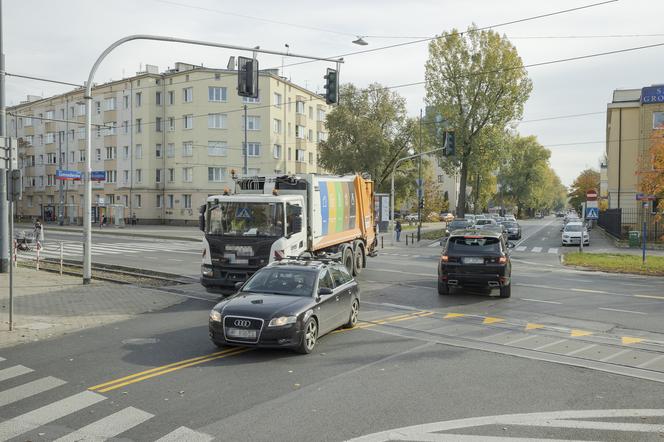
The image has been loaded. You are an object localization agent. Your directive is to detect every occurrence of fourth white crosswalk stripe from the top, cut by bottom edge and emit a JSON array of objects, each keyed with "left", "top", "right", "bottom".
[{"left": 55, "top": 407, "right": 154, "bottom": 442}]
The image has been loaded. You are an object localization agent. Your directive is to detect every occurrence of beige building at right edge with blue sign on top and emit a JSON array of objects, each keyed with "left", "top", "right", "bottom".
[{"left": 600, "top": 86, "right": 664, "bottom": 209}]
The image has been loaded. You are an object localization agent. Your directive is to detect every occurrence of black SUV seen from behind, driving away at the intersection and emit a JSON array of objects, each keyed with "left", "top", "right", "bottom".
[{"left": 438, "top": 229, "right": 514, "bottom": 298}]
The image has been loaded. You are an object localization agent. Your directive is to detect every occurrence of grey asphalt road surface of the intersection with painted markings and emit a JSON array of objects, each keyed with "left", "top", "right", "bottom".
[{"left": 0, "top": 218, "right": 664, "bottom": 441}]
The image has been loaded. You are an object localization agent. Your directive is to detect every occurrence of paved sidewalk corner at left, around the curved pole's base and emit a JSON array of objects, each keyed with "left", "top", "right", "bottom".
[{"left": 0, "top": 267, "right": 185, "bottom": 348}]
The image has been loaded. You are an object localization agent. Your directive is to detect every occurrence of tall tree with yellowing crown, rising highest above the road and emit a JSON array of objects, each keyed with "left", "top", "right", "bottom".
[{"left": 425, "top": 26, "right": 532, "bottom": 216}]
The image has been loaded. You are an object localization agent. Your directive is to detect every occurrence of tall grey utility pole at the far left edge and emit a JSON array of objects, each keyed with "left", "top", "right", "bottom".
[{"left": 0, "top": 0, "right": 7, "bottom": 273}]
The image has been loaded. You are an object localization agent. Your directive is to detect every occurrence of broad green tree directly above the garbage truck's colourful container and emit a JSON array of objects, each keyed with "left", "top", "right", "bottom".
[{"left": 318, "top": 84, "right": 417, "bottom": 193}]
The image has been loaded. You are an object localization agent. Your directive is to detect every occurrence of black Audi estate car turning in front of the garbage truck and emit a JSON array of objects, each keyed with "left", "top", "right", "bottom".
[{"left": 209, "top": 260, "right": 360, "bottom": 353}]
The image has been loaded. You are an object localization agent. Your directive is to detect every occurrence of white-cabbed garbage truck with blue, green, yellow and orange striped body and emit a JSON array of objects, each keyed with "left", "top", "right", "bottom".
[{"left": 199, "top": 174, "right": 377, "bottom": 291}]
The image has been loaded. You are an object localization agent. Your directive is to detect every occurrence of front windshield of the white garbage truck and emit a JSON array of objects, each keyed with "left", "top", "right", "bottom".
[{"left": 207, "top": 201, "right": 284, "bottom": 236}]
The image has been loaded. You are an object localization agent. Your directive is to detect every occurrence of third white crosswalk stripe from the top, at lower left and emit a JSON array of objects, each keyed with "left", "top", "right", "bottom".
[{"left": 0, "top": 391, "right": 106, "bottom": 441}]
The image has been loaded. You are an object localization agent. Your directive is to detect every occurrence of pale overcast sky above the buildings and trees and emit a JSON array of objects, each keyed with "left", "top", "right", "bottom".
[{"left": 5, "top": 0, "right": 664, "bottom": 185}]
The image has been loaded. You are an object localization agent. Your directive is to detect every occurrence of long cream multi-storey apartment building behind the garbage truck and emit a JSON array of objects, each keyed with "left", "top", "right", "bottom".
[{"left": 7, "top": 63, "right": 328, "bottom": 224}]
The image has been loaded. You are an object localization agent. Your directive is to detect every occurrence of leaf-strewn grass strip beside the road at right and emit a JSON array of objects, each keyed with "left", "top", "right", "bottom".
[{"left": 563, "top": 252, "right": 664, "bottom": 276}]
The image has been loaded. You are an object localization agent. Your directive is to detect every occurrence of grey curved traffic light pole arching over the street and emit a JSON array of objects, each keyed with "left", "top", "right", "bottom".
[{"left": 82, "top": 33, "right": 343, "bottom": 284}]
